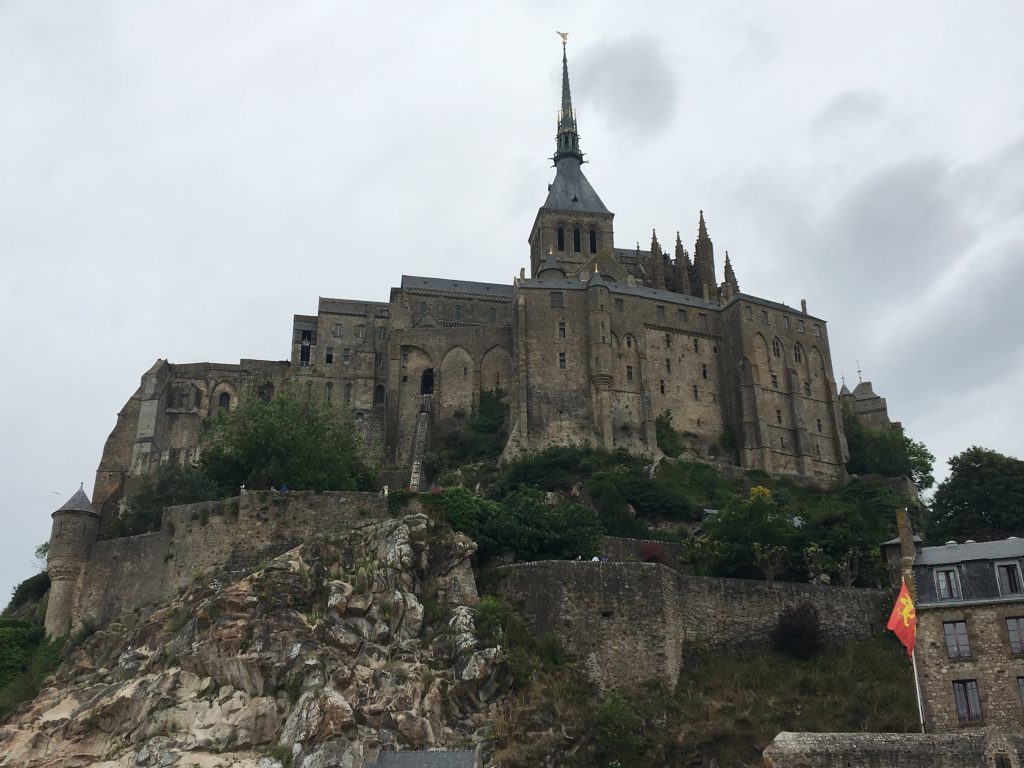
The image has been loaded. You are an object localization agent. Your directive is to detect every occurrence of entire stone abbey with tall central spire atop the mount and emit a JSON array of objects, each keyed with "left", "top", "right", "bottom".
[{"left": 93, "top": 41, "right": 847, "bottom": 520}]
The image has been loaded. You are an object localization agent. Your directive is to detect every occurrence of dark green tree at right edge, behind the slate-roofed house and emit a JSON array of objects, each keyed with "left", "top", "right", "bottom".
[{"left": 928, "top": 445, "right": 1024, "bottom": 542}]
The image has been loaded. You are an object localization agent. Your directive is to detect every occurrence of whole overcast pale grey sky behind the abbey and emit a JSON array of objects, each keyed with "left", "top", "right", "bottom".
[{"left": 0, "top": 0, "right": 1024, "bottom": 597}]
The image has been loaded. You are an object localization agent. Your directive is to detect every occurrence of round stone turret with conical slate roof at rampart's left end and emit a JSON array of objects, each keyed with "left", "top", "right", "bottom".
[{"left": 46, "top": 487, "right": 100, "bottom": 637}]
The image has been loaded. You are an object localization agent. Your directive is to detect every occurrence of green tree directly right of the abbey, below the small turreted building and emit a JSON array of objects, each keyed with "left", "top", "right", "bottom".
[{"left": 843, "top": 409, "right": 935, "bottom": 490}]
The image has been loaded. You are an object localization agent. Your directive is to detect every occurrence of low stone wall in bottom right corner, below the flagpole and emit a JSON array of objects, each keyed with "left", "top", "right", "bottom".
[{"left": 764, "top": 731, "right": 1024, "bottom": 768}]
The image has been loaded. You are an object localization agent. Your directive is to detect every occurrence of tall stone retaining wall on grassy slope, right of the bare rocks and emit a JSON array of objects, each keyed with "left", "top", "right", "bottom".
[{"left": 499, "top": 561, "right": 885, "bottom": 688}]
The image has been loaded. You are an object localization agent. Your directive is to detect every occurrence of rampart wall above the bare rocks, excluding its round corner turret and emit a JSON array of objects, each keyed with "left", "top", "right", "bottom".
[{"left": 74, "top": 490, "right": 390, "bottom": 623}]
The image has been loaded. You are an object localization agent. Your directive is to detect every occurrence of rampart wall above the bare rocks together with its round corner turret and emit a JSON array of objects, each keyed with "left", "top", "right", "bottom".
[{"left": 46, "top": 490, "right": 389, "bottom": 636}]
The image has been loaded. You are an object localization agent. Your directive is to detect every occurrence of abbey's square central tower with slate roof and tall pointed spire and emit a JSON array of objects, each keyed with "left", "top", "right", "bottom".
[{"left": 529, "top": 36, "right": 614, "bottom": 278}]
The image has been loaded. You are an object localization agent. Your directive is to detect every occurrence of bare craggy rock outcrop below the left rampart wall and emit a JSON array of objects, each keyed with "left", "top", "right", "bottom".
[{"left": 0, "top": 514, "right": 511, "bottom": 768}]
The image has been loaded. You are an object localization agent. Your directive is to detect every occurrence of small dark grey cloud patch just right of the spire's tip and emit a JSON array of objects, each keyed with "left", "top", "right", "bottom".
[{"left": 569, "top": 34, "right": 679, "bottom": 136}]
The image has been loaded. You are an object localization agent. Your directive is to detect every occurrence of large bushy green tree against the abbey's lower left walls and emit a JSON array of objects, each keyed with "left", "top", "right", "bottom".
[{"left": 201, "top": 384, "right": 377, "bottom": 495}]
